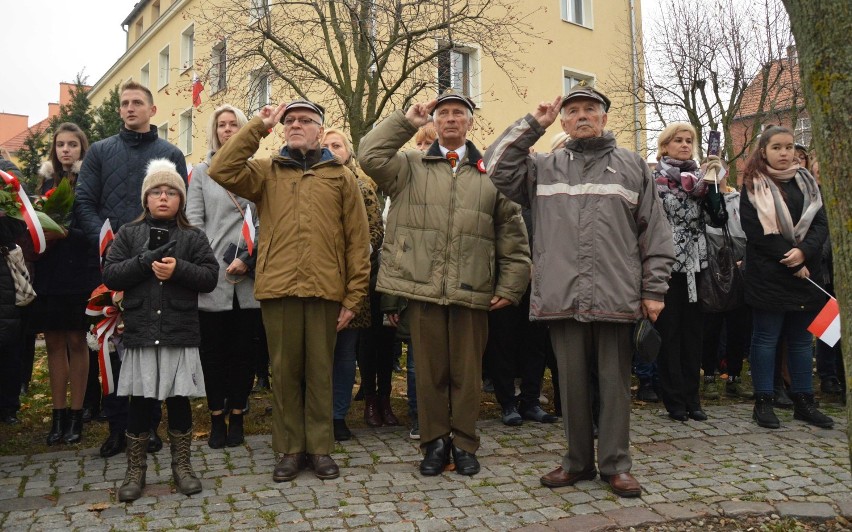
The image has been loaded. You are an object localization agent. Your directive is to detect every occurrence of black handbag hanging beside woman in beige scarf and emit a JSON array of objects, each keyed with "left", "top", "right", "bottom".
[{"left": 696, "top": 225, "right": 745, "bottom": 312}]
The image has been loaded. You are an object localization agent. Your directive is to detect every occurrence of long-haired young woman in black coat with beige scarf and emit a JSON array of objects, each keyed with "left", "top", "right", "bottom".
[{"left": 740, "top": 126, "right": 834, "bottom": 429}]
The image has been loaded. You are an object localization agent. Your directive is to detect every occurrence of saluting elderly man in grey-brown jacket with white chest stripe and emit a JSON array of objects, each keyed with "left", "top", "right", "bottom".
[{"left": 485, "top": 85, "right": 674, "bottom": 497}]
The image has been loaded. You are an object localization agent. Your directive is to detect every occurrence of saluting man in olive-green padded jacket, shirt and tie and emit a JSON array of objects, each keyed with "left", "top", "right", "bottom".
[{"left": 359, "top": 92, "right": 529, "bottom": 475}]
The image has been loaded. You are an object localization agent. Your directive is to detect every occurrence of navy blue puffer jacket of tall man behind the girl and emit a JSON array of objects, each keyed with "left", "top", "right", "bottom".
[{"left": 74, "top": 126, "right": 186, "bottom": 246}]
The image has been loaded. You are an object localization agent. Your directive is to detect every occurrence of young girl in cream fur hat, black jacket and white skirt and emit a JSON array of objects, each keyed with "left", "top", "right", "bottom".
[{"left": 103, "top": 159, "right": 219, "bottom": 501}]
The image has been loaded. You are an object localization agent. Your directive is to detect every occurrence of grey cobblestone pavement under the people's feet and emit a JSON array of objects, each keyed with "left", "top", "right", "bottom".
[{"left": 0, "top": 403, "right": 852, "bottom": 531}]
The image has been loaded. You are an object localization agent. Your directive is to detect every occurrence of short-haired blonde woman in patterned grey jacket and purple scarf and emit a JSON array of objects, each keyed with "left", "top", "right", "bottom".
[{"left": 654, "top": 122, "right": 724, "bottom": 421}]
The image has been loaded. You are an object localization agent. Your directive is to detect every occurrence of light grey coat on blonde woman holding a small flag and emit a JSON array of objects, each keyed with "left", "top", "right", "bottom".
[{"left": 186, "top": 152, "right": 260, "bottom": 312}]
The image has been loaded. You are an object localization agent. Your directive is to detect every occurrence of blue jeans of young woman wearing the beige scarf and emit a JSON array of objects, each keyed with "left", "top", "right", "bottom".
[{"left": 751, "top": 309, "right": 816, "bottom": 394}]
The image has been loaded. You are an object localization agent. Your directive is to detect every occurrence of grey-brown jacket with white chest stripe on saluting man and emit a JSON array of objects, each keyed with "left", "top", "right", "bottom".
[{"left": 485, "top": 115, "right": 674, "bottom": 322}]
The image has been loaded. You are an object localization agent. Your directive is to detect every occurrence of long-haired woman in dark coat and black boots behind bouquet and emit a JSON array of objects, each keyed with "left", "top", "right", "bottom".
[{"left": 29, "top": 122, "right": 100, "bottom": 445}]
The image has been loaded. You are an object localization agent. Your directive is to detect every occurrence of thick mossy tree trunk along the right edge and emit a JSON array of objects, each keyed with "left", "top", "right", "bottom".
[{"left": 783, "top": 0, "right": 852, "bottom": 469}]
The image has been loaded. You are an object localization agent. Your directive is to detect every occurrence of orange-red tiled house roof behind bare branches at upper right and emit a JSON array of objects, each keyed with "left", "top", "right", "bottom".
[{"left": 736, "top": 58, "right": 805, "bottom": 120}]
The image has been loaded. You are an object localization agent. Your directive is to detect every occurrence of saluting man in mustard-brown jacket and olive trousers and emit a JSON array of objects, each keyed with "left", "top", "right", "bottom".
[{"left": 209, "top": 100, "right": 370, "bottom": 482}]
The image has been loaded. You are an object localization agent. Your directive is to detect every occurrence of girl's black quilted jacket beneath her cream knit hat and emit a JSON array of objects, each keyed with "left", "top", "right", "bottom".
[{"left": 103, "top": 216, "right": 219, "bottom": 347}]
